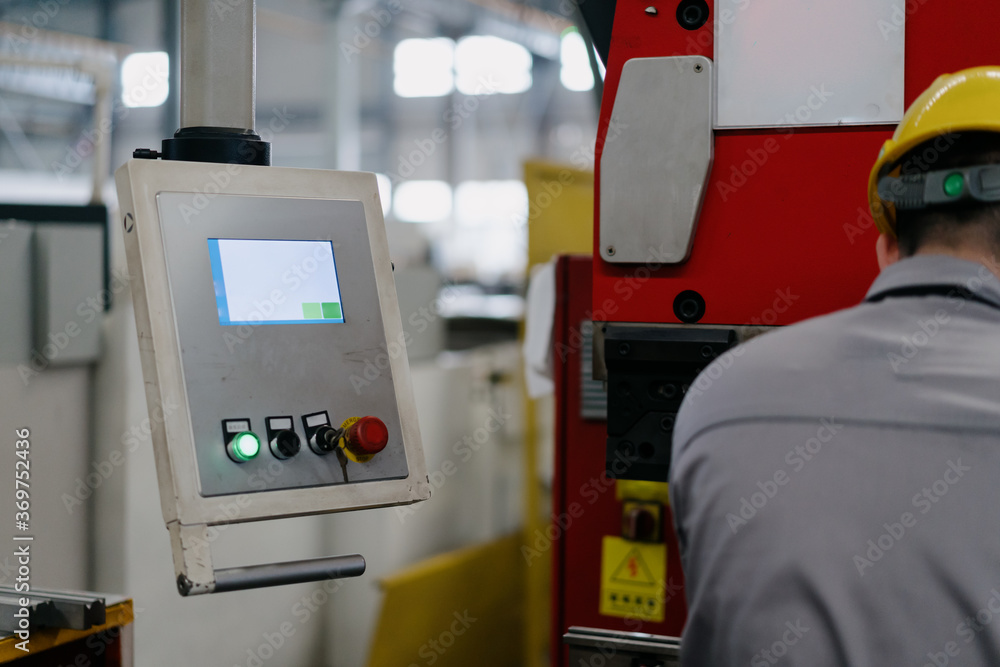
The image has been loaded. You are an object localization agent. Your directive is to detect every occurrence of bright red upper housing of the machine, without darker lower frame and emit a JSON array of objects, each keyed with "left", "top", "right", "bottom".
[{"left": 592, "top": 0, "right": 1000, "bottom": 325}]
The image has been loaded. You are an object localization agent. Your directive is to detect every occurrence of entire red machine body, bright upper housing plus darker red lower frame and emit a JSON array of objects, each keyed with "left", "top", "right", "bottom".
[{"left": 551, "top": 0, "right": 1000, "bottom": 665}]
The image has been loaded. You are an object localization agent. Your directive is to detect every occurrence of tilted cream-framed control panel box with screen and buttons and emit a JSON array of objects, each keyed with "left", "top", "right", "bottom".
[{"left": 116, "top": 160, "right": 430, "bottom": 525}]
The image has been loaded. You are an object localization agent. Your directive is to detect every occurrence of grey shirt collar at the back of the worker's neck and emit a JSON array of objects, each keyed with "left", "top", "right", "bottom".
[{"left": 865, "top": 255, "right": 1000, "bottom": 307}]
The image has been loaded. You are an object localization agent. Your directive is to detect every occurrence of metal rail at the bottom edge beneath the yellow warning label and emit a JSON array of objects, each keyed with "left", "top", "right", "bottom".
[{"left": 563, "top": 627, "right": 681, "bottom": 667}]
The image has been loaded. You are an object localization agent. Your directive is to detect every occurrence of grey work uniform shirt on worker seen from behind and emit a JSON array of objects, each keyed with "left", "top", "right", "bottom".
[{"left": 670, "top": 255, "right": 1000, "bottom": 667}]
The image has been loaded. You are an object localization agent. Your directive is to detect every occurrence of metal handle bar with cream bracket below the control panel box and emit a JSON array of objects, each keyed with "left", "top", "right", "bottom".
[{"left": 167, "top": 521, "right": 366, "bottom": 596}]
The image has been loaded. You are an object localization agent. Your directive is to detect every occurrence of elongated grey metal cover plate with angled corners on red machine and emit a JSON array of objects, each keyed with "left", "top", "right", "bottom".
[{"left": 600, "top": 56, "right": 714, "bottom": 266}]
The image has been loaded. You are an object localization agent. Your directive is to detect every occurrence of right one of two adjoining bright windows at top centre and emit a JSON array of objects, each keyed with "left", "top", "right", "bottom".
[{"left": 455, "top": 36, "right": 531, "bottom": 95}]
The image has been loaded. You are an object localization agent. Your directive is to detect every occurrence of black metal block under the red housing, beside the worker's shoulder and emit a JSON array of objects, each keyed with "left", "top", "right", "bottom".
[{"left": 603, "top": 324, "right": 738, "bottom": 482}]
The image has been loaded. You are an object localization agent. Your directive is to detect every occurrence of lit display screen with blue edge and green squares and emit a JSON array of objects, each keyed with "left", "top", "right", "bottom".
[{"left": 208, "top": 239, "right": 344, "bottom": 325}]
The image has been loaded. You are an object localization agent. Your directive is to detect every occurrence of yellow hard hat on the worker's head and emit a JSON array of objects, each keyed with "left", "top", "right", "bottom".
[{"left": 868, "top": 67, "right": 1000, "bottom": 236}]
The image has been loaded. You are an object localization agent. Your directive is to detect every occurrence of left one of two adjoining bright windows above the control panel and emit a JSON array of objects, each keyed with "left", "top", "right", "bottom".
[{"left": 393, "top": 37, "right": 455, "bottom": 97}]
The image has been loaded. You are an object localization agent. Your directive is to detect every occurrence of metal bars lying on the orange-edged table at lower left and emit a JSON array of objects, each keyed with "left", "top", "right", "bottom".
[{"left": 0, "top": 586, "right": 106, "bottom": 632}]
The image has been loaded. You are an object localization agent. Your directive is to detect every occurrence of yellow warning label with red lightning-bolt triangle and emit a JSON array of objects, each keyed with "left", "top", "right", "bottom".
[{"left": 601, "top": 536, "right": 667, "bottom": 622}]
